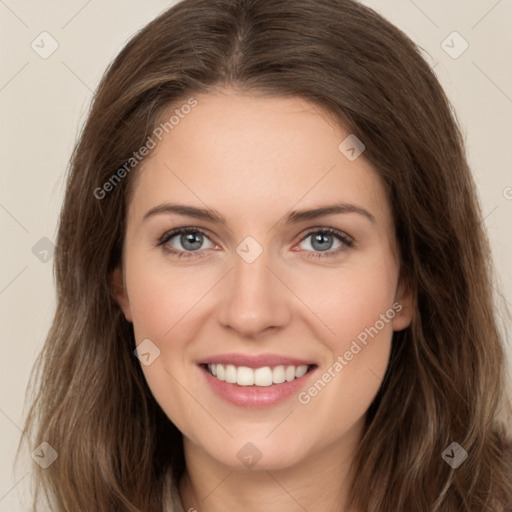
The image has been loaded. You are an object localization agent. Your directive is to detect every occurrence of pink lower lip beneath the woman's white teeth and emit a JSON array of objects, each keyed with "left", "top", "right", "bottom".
[{"left": 200, "top": 366, "right": 316, "bottom": 408}]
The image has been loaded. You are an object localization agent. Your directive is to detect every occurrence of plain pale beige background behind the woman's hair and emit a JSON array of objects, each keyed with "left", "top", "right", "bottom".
[{"left": 0, "top": 0, "right": 512, "bottom": 512}]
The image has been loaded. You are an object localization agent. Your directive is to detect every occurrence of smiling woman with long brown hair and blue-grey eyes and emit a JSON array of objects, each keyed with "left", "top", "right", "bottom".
[{"left": 20, "top": 0, "right": 512, "bottom": 512}]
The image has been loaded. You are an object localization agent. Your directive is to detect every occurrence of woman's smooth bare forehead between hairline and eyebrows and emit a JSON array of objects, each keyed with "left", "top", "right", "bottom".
[{"left": 130, "top": 91, "right": 390, "bottom": 230}]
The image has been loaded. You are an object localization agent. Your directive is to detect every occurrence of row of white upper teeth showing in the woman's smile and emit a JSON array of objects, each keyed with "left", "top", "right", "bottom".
[{"left": 208, "top": 364, "right": 308, "bottom": 387}]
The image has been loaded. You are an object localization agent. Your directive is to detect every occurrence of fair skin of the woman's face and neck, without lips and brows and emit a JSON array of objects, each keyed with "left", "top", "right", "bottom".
[{"left": 112, "top": 89, "right": 412, "bottom": 512}]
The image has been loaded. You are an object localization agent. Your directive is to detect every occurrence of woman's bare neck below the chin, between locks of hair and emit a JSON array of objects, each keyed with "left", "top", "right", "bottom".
[{"left": 180, "top": 425, "right": 362, "bottom": 512}]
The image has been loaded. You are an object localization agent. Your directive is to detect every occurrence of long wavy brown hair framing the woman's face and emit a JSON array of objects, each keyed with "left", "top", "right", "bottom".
[{"left": 20, "top": 0, "right": 512, "bottom": 512}]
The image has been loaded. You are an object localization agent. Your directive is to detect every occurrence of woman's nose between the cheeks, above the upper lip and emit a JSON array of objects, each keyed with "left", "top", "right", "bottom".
[{"left": 217, "top": 251, "right": 292, "bottom": 339}]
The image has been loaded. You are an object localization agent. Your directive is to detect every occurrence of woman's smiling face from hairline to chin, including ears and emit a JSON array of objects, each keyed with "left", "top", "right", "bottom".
[{"left": 113, "top": 90, "right": 411, "bottom": 469}]
